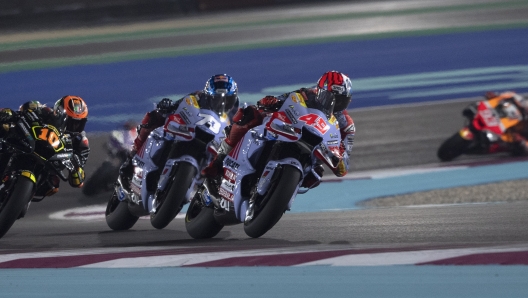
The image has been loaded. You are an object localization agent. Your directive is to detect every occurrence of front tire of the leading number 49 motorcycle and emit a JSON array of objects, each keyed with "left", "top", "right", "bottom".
[{"left": 244, "top": 165, "right": 301, "bottom": 238}]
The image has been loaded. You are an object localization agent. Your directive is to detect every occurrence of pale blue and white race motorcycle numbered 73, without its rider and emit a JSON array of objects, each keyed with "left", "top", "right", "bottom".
[{"left": 105, "top": 95, "right": 229, "bottom": 230}]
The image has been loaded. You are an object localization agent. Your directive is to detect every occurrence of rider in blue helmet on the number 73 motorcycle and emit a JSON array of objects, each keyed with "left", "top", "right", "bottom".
[{"left": 119, "top": 74, "right": 239, "bottom": 190}]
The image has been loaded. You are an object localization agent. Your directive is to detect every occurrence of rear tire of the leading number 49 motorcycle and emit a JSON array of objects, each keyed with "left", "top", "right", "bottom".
[{"left": 185, "top": 196, "right": 224, "bottom": 239}]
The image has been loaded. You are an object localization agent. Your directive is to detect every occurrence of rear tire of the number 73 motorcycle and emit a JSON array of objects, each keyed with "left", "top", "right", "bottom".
[{"left": 105, "top": 190, "right": 139, "bottom": 231}]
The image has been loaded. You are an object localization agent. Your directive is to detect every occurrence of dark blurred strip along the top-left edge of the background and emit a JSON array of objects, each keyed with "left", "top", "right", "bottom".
[{"left": 0, "top": 0, "right": 350, "bottom": 31}]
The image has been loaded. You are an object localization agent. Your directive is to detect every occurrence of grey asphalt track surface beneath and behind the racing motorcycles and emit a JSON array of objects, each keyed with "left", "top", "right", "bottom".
[{"left": 1, "top": 93, "right": 528, "bottom": 253}]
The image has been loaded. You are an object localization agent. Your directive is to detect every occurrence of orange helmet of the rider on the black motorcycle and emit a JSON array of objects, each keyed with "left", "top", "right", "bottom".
[{"left": 53, "top": 95, "right": 88, "bottom": 132}]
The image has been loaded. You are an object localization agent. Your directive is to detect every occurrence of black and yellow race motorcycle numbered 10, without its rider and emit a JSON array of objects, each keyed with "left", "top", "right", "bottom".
[{"left": 0, "top": 110, "right": 79, "bottom": 238}]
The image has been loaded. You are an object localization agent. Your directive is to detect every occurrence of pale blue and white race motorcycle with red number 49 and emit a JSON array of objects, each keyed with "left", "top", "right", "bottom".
[{"left": 185, "top": 93, "right": 348, "bottom": 239}]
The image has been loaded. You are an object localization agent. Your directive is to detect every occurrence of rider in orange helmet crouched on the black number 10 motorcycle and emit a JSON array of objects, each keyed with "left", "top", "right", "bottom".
[{"left": 0, "top": 95, "right": 90, "bottom": 196}]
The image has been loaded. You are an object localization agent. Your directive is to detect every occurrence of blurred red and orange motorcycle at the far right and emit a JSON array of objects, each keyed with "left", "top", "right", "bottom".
[{"left": 437, "top": 96, "right": 523, "bottom": 161}]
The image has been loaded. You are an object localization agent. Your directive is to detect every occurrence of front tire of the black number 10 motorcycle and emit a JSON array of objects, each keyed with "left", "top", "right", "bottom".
[{"left": 0, "top": 176, "right": 34, "bottom": 238}]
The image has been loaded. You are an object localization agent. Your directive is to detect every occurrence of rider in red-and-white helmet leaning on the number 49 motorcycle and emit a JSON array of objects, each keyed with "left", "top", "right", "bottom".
[{"left": 202, "top": 71, "right": 356, "bottom": 188}]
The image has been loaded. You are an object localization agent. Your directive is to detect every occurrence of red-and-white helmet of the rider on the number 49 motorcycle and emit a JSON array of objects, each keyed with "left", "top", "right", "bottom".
[{"left": 316, "top": 70, "right": 352, "bottom": 112}]
